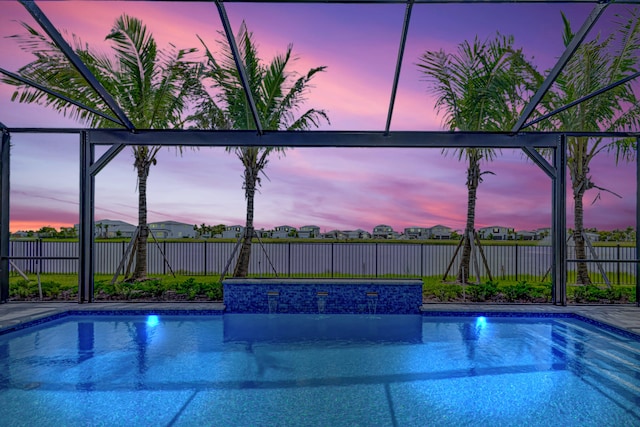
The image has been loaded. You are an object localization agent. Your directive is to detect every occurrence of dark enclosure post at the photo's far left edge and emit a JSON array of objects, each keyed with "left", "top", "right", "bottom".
[{"left": 0, "top": 128, "right": 11, "bottom": 303}]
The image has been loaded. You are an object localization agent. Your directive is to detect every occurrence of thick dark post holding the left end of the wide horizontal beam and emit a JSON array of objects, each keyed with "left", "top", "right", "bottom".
[{"left": 78, "top": 131, "right": 95, "bottom": 304}]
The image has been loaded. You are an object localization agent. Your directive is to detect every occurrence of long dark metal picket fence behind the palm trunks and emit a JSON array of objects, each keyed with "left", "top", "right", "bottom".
[{"left": 9, "top": 240, "right": 636, "bottom": 284}]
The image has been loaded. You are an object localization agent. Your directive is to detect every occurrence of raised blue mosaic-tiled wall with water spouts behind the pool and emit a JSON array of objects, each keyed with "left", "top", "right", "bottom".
[{"left": 222, "top": 279, "right": 422, "bottom": 314}]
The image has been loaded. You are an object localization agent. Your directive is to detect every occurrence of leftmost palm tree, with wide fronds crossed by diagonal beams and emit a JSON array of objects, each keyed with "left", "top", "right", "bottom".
[{"left": 3, "top": 15, "right": 197, "bottom": 280}]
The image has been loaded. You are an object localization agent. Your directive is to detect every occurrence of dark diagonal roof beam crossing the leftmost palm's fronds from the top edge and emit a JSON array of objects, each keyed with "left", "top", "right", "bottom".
[{"left": 18, "top": 0, "right": 135, "bottom": 130}]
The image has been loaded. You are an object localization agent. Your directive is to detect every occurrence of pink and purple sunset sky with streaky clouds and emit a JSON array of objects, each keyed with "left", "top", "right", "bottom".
[{"left": 0, "top": 0, "right": 636, "bottom": 231}]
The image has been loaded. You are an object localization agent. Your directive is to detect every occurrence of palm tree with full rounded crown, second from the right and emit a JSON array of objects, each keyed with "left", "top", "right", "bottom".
[{"left": 417, "top": 34, "right": 527, "bottom": 283}]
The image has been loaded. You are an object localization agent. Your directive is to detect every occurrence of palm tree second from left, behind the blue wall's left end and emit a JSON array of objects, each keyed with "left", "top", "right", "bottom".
[{"left": 191, "top": 22, "right": 329, "bottom": 277}]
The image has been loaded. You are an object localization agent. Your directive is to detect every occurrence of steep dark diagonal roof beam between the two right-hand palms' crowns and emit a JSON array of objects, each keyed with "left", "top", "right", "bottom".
[{"left": 512, "top": 2, "right": 609, "bottom": 132}]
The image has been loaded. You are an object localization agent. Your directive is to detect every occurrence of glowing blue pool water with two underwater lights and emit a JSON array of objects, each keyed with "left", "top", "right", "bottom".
[{"left": 0, "top": 314, "right": 640, "bottom": 427}]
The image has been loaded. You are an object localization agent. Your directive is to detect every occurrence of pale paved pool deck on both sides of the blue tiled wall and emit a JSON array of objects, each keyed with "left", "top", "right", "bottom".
[{"left": 0, "top": 302, "right": 640, "bottom": 335}]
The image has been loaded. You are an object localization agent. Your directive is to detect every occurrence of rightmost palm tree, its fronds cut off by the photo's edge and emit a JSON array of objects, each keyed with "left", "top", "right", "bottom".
[{"left": 533, "top": 9, "right": 640, "bottom": 285}]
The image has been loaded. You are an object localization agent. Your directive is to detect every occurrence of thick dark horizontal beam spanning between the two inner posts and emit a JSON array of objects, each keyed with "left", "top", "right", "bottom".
[{"left": 87, "top": 129, "right": 559, "bottom": 149}]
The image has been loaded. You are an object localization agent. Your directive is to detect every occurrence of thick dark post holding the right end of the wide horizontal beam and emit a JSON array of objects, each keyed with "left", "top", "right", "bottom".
[{"left": 551, "top": 135, "right": 567, "bottom": 305}]
